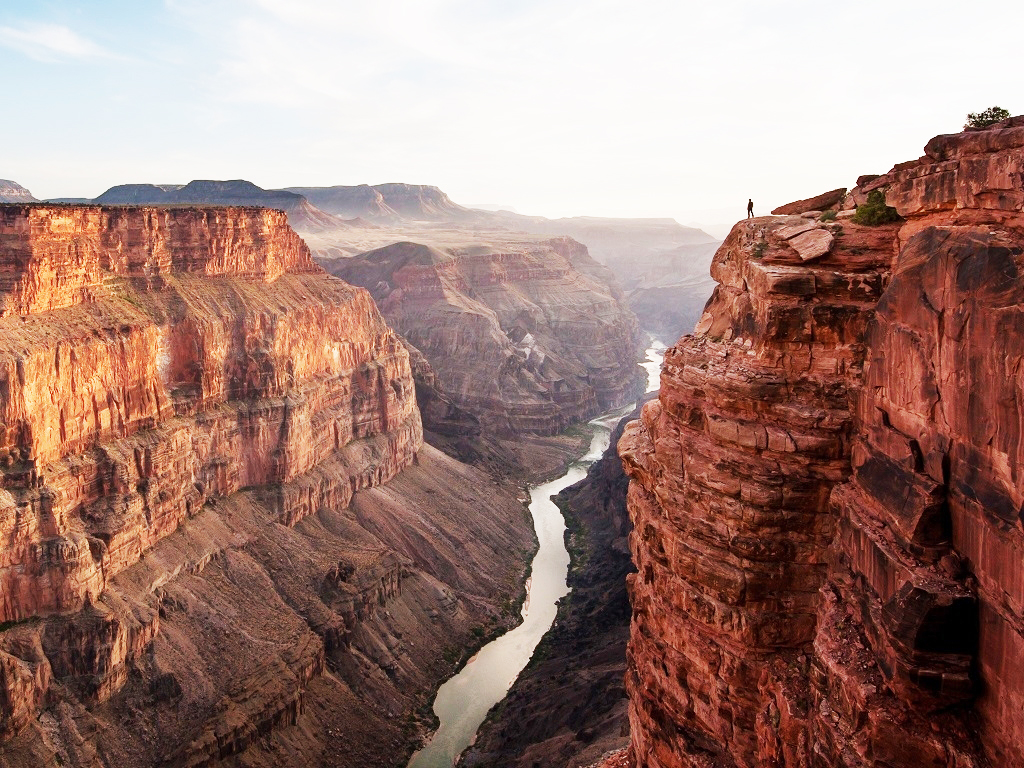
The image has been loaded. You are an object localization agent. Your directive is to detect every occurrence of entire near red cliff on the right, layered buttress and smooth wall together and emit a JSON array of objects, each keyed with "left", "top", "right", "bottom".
[{"left": 620, "top": 118, "right": 1024, "bottom": 768}]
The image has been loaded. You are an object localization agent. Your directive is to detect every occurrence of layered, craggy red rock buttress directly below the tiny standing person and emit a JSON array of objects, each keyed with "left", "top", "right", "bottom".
[{"left": 620, "top": 211, "right": 894, "bottom": 768}]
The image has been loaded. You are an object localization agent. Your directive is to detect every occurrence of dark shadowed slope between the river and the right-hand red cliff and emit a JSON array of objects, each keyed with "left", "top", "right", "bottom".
[{"left": 460, "top": 395, "right": 653, "bottom": 768}]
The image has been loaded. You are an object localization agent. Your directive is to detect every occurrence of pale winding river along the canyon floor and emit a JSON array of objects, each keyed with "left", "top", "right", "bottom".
[{"left": 409, "top": 340, "right": 665, "bottom": 768}]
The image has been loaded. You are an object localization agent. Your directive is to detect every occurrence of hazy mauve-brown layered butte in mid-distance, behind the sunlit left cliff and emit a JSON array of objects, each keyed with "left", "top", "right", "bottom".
[{"left": 329, "top": 239, "right": 644, "bottom": 434}]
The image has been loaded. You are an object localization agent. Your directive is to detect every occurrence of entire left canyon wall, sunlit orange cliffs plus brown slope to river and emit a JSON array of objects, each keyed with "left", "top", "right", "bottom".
[{"left": 0, "top": 205, "right": 531, "bottom": 766}]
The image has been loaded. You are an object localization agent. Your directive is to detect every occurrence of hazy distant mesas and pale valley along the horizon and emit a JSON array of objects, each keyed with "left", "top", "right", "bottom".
[{"left": 14, "top": 180, "right": 720, "bottom": 343}]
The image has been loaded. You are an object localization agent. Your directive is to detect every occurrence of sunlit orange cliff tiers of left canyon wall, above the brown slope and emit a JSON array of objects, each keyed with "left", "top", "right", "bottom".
[{"left": 0, "top": 206, "right": 421, "bottom": 622}]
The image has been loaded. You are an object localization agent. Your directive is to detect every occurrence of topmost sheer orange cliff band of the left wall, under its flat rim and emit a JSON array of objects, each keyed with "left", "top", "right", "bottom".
[{"left": 0, "top": 204, "right": 316, "bottom": 314}]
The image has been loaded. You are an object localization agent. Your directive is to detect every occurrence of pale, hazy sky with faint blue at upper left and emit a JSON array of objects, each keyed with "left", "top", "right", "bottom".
[{"left": 0, "top": 0, "right": 1024, "bottom": 234}]
